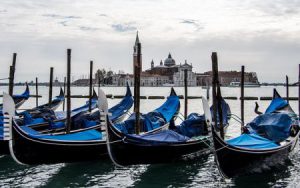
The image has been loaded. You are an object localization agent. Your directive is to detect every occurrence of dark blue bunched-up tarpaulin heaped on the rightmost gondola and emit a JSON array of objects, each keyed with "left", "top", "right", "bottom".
[{"left": 247, "top": 113, "right": 292, "bottom": 142}]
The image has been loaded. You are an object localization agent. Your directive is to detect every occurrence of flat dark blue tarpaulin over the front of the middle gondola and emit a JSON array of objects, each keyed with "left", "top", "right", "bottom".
[{"left": 130, "top": 130, "right": 190, "bottom": 142}]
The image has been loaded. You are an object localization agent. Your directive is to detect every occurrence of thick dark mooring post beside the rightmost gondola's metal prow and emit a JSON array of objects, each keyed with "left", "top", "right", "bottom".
[{"left": 211, "top": 52, "right": 224, "bottom": 139}]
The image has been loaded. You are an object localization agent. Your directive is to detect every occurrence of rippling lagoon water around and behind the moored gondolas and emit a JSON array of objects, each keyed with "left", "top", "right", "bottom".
[{"left": 0, "top": 86, "right": 300, "bottom": 188}]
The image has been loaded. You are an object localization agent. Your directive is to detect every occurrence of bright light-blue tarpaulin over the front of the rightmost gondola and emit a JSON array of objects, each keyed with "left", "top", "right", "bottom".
[{"left": 226, "top": 134, "right": 279, "bottom": 149}]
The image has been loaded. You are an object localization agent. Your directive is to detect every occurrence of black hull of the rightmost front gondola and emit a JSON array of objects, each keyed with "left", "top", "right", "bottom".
[{"left": 212, "top": 131, "right": 299, "bottom": 178}]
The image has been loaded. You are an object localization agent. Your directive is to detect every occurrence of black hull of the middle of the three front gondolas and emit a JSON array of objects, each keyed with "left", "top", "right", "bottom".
[{"left": 107, "top": 118, "right": 210, "bottom": 166}]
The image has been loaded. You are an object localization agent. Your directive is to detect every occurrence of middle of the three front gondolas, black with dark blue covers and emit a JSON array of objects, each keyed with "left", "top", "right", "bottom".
[{"left": 107, "top": 93, "right": 230, "bottom": 166}]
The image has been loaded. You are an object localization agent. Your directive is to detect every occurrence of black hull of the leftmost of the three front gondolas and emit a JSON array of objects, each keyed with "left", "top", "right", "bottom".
[{"left": 10, "top": 120, "right": 107, "bottom": 165}]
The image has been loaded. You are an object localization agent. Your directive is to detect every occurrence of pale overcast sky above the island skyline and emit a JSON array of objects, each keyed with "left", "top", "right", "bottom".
[{"left": 0, "top": 0, "right": 300, "bottom": 82}]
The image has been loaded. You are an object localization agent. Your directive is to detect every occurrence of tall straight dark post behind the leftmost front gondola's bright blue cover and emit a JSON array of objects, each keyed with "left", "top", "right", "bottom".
[{"left": 66, "top": 49, "right": 71, "bottom": 133}]
